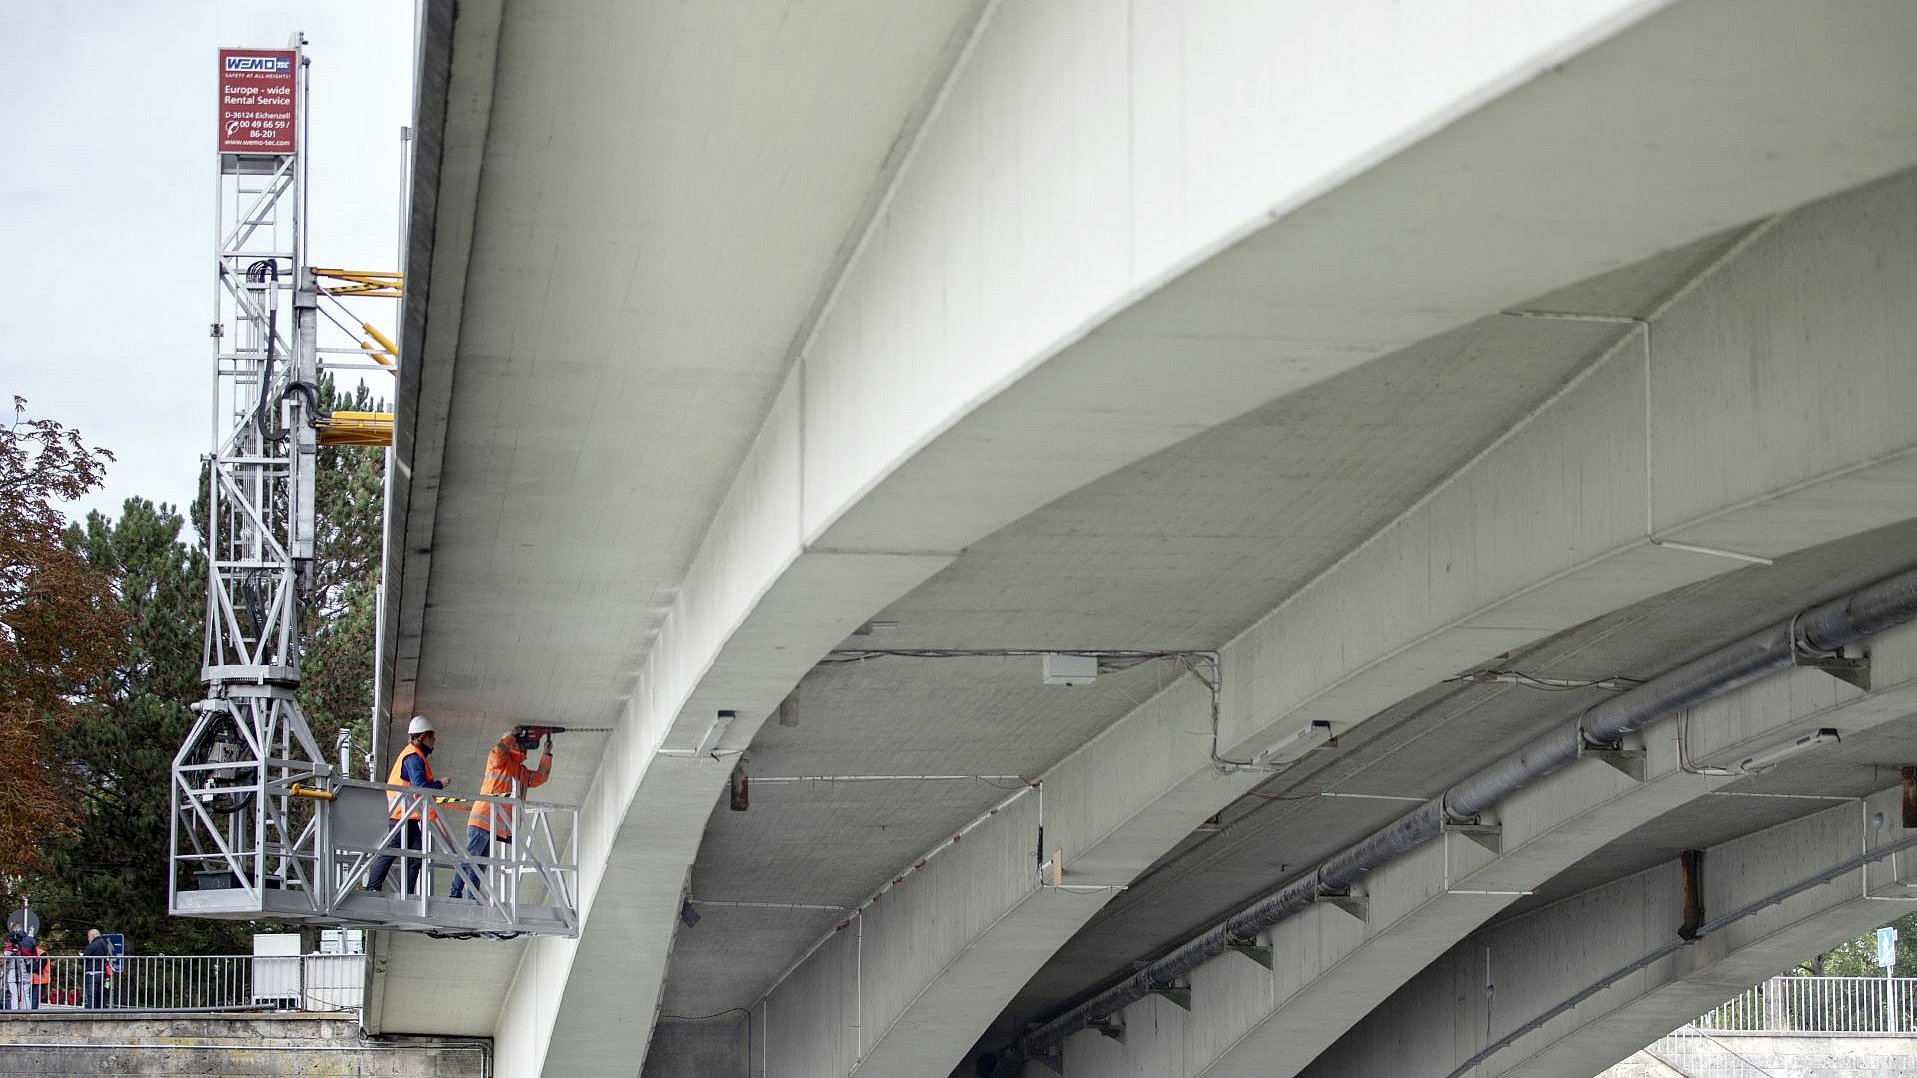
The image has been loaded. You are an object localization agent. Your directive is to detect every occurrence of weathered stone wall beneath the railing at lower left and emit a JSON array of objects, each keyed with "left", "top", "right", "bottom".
[{"left": 0, "top": 1011, "right": 493, "bottom": 1078}]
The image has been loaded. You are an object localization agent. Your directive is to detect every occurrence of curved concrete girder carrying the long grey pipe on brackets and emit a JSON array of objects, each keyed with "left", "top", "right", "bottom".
[{"left": 1066, "top": 613, "right": 1917, "bottom": 1078}]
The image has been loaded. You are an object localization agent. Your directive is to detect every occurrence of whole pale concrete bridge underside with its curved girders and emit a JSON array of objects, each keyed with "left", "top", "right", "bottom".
[{"left": 368, "top": 0, "right": 1917, "bottom": 1078}]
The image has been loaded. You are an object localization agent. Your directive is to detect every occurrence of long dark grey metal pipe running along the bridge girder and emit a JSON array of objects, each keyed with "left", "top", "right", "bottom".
[{"left": 1020, "top": 570, "right": 1917, "bottom": 1055}]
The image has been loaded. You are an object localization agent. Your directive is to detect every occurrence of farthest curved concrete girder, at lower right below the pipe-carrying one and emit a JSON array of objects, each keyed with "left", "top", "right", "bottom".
[{"left": 1304, "top": 774, "right": 1917, "bottom": 1078}]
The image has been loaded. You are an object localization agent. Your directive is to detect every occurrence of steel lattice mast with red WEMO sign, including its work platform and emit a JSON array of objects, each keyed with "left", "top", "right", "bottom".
[{"left": 167, "top": 35, "right": 579, "bottom": 936}]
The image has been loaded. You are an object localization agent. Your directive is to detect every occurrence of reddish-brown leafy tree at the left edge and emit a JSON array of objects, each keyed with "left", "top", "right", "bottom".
[{"left": 0, "top": 397, "right": 127, "bottom": 877}]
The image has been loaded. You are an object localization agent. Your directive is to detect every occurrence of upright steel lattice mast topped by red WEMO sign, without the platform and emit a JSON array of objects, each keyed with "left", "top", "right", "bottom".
[{"left": 171, "top": 35, "right": 332, "bottom": 911}]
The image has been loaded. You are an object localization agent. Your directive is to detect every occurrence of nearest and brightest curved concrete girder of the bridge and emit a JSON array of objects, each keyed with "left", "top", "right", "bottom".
[{"left": 483, "top": 0, "right": 1917, "bottom": 1074}]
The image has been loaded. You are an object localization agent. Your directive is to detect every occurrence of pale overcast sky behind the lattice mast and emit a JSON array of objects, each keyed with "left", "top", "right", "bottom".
[{"left": 0, "top": 0, "right": 414, "bottom": 518}]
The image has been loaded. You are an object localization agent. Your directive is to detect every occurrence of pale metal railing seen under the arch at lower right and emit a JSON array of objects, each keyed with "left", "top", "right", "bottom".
[{"left": 1693, "top": 976, "right": 1917, "bottom": 1036}]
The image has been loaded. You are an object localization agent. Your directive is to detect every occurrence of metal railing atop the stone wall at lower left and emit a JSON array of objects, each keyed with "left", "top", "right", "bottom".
[{"left": 0, "top": 955, "right": 366, "bottom": 1013}]
